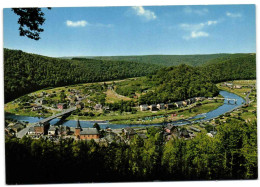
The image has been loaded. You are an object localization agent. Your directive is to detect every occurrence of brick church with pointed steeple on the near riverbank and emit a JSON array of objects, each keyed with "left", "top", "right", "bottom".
[{"left": 75, "top": 120, "right": 100, "bottom": 140}]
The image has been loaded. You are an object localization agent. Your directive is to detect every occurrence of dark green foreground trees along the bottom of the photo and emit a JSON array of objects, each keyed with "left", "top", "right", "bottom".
[{"left": 5, "top": 120, "right": 258, "bottom": 184}]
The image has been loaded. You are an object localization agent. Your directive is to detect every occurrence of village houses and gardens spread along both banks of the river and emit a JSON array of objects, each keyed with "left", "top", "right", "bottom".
[{"left": 5, "top": 82, "right": 252, "bottom": 143}]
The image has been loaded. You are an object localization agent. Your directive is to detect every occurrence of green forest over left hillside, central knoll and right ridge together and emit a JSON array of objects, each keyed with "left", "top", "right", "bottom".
[{"left": 4, "top": 49, "right": 256, "bottom": 103}]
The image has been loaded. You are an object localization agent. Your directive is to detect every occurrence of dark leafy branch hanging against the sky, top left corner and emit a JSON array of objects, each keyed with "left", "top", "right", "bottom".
[{"left": 12, "top": 8, "right": 51, "bottom": 40}]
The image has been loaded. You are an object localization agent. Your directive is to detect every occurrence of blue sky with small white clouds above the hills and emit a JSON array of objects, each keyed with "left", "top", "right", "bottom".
[{"left": 4, "top": 5, "right": 256, "bottom": 57}]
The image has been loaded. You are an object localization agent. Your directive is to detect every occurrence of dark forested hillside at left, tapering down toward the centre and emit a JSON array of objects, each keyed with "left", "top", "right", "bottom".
[{"left": 4, "top": 49, "right": 160, "bottom": 102}]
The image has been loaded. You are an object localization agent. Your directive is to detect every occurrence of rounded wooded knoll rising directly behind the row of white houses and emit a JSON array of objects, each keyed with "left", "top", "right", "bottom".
[{"left": 139, "top": 65, "right": 218, "bottom": 104}]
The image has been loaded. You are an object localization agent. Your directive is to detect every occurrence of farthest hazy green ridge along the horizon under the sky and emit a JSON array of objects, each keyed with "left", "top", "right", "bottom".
[{"left": 64, "top": 53, "right": 251, "bottom": 66}]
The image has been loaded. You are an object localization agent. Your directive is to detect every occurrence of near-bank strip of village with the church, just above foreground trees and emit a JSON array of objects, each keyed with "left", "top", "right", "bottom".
[{"left": 5, "top": 117, "right": 216, "bottom": 143}]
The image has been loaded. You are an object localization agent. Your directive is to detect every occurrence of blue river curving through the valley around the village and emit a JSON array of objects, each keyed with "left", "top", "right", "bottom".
[{"left": 5, "top": 91, "right": 245, "bottom": 129}]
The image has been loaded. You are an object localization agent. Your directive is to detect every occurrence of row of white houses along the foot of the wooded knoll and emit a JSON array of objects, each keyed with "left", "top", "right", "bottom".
[{"left": 140, "top": 97, "right": 206, "bottom": 111}]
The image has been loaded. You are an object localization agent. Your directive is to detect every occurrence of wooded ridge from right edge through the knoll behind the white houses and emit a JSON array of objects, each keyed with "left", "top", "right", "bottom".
[{"left": 140, "top": 54, "right": 256, "bottom": 104}]
